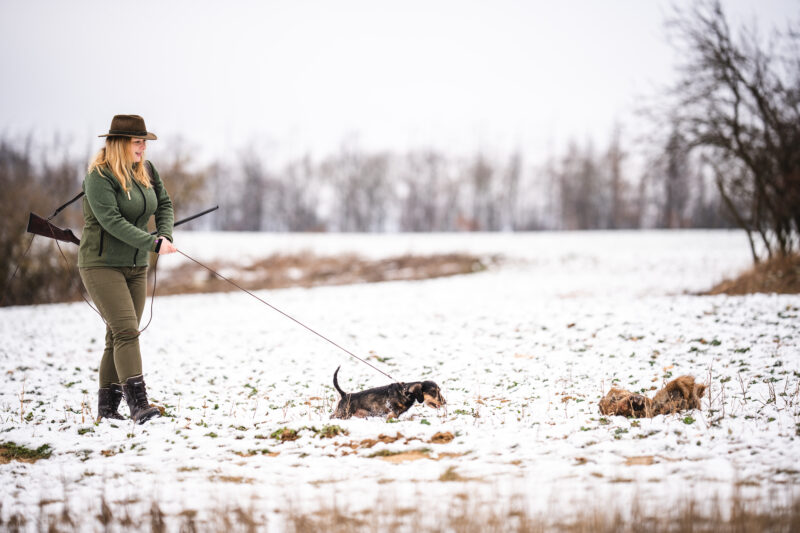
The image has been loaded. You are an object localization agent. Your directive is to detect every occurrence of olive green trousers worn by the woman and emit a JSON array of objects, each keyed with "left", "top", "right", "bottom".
[{"left": 79, "top": 266, "right": 147, "bottom": 388}]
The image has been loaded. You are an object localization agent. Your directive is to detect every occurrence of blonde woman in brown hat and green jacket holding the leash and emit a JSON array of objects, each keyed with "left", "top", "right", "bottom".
[{"left": 78, "top": 115, "right": 177, "bottom": 424}]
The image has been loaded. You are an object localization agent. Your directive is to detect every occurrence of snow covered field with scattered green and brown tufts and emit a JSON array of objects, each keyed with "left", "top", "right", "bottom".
[{"left": 0, "top": 231, "right": 800, "bottom": 531}]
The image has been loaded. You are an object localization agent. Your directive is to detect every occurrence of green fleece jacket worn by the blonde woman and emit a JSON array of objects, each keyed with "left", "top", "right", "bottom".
[{"left": 78, "top": 161, "right": 173, "bottom": 267}]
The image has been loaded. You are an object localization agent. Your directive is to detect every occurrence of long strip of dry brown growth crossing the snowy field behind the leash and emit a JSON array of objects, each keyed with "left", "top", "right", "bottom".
[{"left": 158, "top": 253, "right": 499, "bottom": 295}]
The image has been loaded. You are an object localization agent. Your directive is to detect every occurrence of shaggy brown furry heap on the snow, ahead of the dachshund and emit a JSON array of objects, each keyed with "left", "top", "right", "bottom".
[{"left": 599, "top": 376, "right": 707, "bottom": 418}]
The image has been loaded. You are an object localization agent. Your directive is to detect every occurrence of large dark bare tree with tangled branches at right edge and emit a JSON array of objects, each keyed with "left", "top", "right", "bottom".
[{"left": 669, "top": 0, "right": 800, "bottom": 262}]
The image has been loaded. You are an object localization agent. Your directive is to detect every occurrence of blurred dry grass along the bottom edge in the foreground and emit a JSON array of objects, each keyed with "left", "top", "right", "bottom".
[{"left": 0, "top": 486, "right": 800, "bottom": 533}]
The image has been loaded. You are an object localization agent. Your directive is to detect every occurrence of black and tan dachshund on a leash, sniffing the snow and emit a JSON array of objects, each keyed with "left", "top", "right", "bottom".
[{"left": 331, "top": 367, "right": 447, "bottom": 418}]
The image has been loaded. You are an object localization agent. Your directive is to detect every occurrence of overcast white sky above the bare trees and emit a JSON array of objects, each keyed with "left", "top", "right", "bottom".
[{"left": 0, "top": 0, "right": 800, "bottom": 164}]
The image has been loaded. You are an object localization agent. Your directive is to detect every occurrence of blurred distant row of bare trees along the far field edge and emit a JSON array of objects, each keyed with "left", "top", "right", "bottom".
[{"left": 213, "top": 135, "right": 730, "bottom": 232}]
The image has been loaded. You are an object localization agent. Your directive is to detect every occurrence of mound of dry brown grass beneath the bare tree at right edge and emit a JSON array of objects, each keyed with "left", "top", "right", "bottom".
[{"left": 704, "top": 254, "right": 800, "bottom": 296}]
